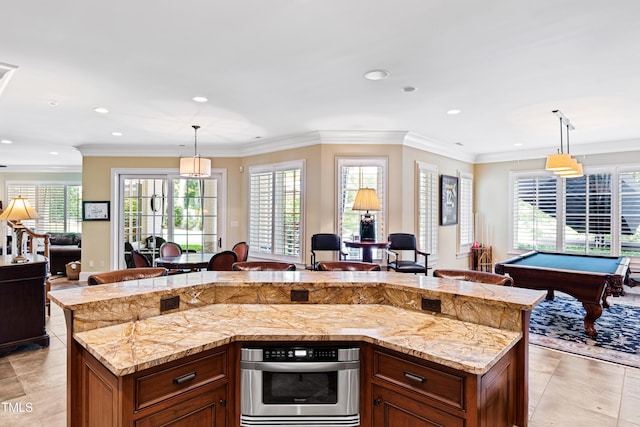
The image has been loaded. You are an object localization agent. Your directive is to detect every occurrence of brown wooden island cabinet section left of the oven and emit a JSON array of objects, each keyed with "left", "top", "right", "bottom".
[{"left": 79, "top": 347, "right": 233, "bottom": 427}]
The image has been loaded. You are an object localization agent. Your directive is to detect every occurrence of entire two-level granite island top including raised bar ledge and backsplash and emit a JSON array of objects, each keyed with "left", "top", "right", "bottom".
[{"left": 49, "top": 271, "right": 546, "bottom": 375}]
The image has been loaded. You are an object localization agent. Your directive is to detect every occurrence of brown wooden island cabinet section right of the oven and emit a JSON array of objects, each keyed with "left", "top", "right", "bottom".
[{"left": 361, "top": 346, "right": 517, "bottom": 427}]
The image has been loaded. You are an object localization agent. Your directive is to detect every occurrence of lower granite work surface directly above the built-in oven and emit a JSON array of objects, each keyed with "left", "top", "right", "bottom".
[{"left": 74, "top": 304, "right": 521, "bottom": 376}]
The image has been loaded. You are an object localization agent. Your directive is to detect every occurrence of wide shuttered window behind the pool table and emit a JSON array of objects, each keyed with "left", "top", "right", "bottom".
[{"left": 510, "top": 167, "right": 640, "bottom": 256}]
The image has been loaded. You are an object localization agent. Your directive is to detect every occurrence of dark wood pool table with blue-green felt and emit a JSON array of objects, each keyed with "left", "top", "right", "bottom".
[{"left": 495, "top": 251, "right": 629, "bottom": 337}]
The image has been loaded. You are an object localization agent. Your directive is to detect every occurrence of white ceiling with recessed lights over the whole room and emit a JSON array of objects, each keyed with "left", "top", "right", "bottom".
[{"left": 0, "top": 0, "right": 640, "bottom": 171}]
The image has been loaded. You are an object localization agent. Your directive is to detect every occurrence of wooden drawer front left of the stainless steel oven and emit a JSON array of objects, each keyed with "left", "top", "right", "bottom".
[{"left": 135, "top": 351, "right": 227, "bottom": 410}]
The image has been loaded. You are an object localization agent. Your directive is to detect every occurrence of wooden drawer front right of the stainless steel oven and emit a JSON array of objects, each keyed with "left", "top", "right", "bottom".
[{"left": 373, "top": 351, "right": 464, "bottom": 409}]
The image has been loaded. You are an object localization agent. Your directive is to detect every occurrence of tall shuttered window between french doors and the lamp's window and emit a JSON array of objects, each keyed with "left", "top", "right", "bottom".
[{"left": 249, "top": 161, "right": 304, "bottom": 262}]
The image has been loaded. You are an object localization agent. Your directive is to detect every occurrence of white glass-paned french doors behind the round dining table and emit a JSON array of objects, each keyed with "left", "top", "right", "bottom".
[{"left": 117, "top": 172, "right": 224, "bottom": 268}]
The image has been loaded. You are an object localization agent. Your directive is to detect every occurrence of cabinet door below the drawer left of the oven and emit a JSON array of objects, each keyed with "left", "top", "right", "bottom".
[{"left": 136, "top": 384, "right": 227, "bottom": 427}]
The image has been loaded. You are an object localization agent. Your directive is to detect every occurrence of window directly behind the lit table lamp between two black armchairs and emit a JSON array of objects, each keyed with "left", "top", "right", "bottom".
[{"left": 337, "top": 158, "right": 387, "bottom": 259}]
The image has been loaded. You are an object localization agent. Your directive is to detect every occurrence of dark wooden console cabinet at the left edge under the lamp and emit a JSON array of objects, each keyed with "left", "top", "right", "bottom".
[{"left": 0, "top": 255, "right": 49, "bottom": 356}]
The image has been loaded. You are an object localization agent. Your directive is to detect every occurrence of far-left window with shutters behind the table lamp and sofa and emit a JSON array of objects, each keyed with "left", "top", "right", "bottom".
[{"left": 7, "top": 183, "right": 82, "bottom": 233}]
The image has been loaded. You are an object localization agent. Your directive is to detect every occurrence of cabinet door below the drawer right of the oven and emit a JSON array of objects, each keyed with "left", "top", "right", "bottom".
[{"left": 372, "top": 384, "right": 464, "bottom": 427}]
